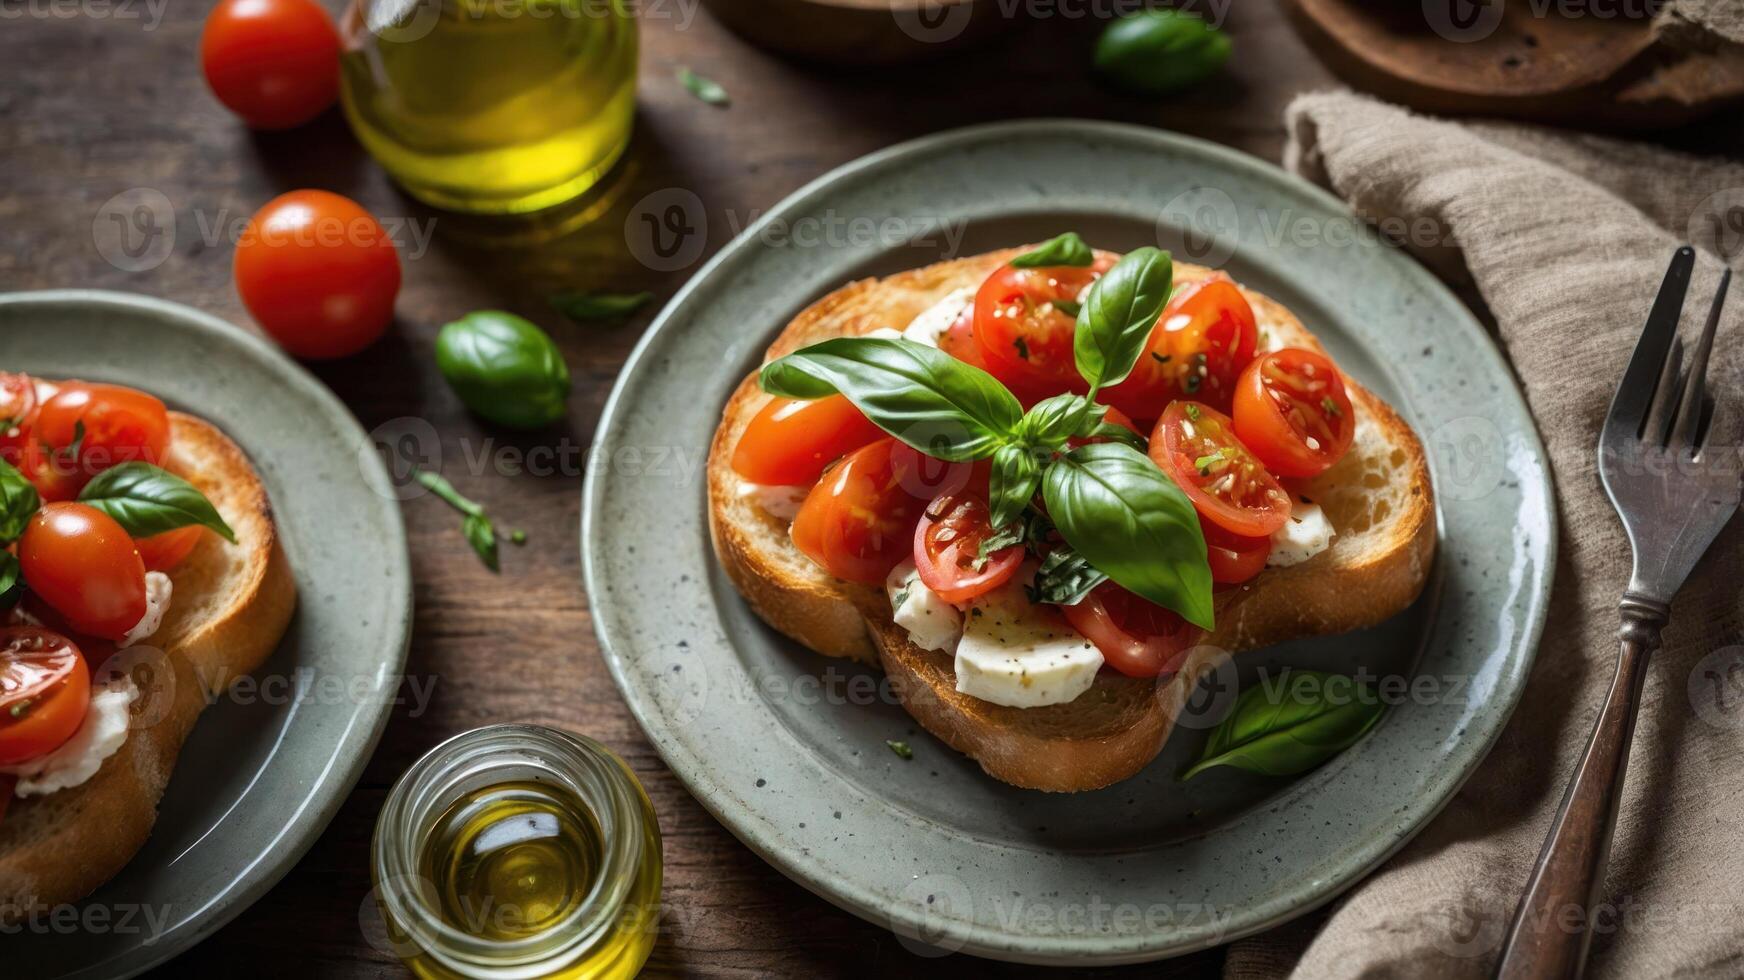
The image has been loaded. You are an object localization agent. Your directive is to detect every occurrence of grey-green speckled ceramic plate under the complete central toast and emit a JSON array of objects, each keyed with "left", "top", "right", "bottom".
[{"left": 582, "top": 120, "right": 1556, "bottom": 964}]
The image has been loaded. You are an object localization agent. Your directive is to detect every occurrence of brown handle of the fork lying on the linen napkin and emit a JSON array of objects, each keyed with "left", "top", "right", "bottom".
[{"left": 1496, "top": 593, "right": 1671, "bottom": 980}]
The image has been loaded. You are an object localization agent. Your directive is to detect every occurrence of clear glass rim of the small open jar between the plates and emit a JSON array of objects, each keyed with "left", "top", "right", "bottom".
[{"left": 371, "top": 724, "right": 645, "bottom": 975}]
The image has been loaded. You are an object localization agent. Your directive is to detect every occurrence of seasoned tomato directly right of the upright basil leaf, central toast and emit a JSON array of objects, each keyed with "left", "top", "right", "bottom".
[{"left": 1104, "top": 272, "right": 1259, "bottom": 419}]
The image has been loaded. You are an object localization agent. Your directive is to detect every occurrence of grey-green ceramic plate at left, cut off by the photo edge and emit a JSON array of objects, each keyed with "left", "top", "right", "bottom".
[{"left": 0, "top": 289, "right": 412, "bottom": 980}]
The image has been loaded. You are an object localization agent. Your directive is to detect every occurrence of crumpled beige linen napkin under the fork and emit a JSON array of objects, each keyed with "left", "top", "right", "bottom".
[{"left": 1226, "top": 94, "right": 1744, "bottom": 978}]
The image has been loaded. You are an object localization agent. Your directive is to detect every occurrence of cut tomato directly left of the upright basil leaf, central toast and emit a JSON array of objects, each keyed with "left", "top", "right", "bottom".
[{"left": 975, "top": 265, "right": 1097, "bottom": 392}]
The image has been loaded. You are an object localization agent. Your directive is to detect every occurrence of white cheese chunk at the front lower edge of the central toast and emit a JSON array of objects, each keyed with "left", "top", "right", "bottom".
[{"left": 956, "top": 565, "right": 1102, "bottom": 708}]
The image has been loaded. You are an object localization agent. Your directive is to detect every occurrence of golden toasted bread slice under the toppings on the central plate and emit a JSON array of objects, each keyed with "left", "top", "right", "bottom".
[{"left": 708, "top": 249, "right": 1435, "bottom": 792}]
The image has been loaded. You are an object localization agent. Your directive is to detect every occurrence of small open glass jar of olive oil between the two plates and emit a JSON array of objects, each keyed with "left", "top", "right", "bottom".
[{"left": 371, "top": 725, "right": 661, "bottom": 980}]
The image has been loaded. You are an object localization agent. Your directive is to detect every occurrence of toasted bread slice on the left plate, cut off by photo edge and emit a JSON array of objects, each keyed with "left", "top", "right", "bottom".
[{"left": 0, "top": 412, "right": 296, "bottom": 921}]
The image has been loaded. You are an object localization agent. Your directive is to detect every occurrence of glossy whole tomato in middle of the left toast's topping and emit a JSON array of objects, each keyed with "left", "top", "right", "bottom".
[{"left": 17, "top": 504, "right": 145, "bottom": 640}]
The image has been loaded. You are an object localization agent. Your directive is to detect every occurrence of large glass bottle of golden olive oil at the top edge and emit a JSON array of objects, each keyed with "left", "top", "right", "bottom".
[{"left": 342, "top": 0, "right": 637, "bottom": 214}]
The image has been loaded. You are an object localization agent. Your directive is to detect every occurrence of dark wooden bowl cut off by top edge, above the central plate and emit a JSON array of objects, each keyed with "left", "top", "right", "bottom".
[{"left": 703, "top": 0, "right": 1018, "bottom": 65}]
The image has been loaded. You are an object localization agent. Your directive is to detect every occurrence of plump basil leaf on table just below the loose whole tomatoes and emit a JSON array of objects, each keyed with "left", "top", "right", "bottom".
[{"left": 436, "top": 310, "right": 569, "bottom": 429}]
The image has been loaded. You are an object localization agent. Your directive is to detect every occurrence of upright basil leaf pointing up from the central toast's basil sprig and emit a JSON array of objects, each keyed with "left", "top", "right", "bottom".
[{"left": 1073, "top": 246, "right": 1175, "bottom": 391}]
